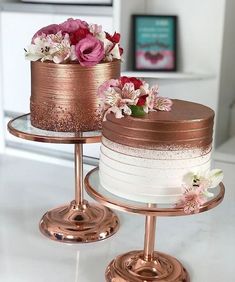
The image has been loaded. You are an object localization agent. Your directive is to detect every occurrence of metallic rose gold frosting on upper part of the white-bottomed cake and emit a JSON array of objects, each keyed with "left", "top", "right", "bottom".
[{"left": 102, "top": 100, "right": 214, "bottom": 150}]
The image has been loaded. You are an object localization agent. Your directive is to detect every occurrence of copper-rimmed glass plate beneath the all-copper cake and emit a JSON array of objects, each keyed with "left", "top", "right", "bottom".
[{"left": 8, "top": 114, "right": 101, "bottom": 144}]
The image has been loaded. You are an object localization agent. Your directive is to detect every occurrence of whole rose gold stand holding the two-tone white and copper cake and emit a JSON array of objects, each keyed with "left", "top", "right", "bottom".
[{"left": 85, "top": 168, "right": 225, "bottom": 282}]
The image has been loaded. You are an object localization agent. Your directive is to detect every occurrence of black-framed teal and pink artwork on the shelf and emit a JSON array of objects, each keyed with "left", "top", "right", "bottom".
[{"left": 133, "top": 15, "right": 177, "bottom": 71}]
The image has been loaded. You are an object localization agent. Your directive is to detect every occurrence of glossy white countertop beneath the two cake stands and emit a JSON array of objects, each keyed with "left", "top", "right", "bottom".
[{"left": 0, "top": 155, "right": 235, "bottom": 282}]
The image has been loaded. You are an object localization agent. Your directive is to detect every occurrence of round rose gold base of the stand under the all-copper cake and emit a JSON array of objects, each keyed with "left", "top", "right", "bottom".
[{"left": 39, "top": 200, "right": 119, "bottom": 243}]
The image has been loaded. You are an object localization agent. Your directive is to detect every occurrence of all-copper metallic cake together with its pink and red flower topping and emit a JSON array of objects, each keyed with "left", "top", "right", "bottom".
[{"left": 25, "top": 18, "right": 123, "bottom": 132}]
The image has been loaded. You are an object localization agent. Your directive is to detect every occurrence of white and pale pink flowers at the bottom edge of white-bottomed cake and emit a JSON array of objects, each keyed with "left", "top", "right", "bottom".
[{"left": 176, "top": 169, "right": 223, "bottom": 214}]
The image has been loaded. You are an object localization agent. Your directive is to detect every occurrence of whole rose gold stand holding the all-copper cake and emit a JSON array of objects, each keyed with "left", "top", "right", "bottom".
[{"left": 8, "top": 114, "right": 119, "bottom": 243}]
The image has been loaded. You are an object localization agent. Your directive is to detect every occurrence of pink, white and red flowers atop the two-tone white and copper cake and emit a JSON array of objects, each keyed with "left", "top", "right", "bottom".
[{"left": 98, "top": 76, "right": 172, "bottom": 120}]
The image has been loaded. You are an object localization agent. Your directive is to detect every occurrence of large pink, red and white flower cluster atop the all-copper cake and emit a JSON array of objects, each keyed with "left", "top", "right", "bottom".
[{"left": 25, "top": 18, "right": 123, "bottom": 66}]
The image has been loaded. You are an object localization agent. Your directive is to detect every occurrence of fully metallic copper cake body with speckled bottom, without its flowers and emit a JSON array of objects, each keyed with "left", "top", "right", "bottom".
[{"left": 30, "top": 60, "right": 120, "bottom": 132}]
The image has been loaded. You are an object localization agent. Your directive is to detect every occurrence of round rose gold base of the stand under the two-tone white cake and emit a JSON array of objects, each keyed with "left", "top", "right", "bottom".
[{"left": 105, "top": 251, "right": 190, "bottom": 282}]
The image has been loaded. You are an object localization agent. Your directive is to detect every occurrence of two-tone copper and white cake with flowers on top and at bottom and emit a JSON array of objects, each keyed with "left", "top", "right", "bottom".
[{"left": 99, "top": 77, "right": 223, "bottom": 206}]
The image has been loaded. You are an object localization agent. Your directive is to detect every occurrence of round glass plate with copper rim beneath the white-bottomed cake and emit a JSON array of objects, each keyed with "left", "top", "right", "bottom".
[{"left": 85, "top": 168, "right": 225, "bottom": 216}]
